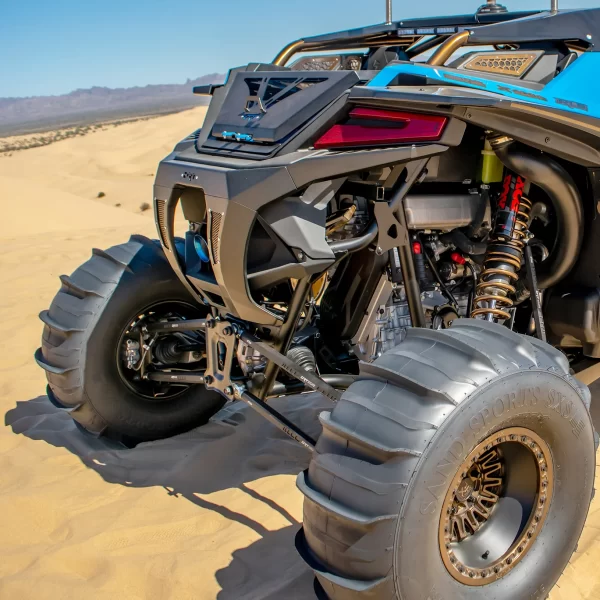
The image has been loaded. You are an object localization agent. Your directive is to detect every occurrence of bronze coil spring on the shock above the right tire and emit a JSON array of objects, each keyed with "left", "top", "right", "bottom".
[{"left": 471, "top": 196, "right": 531, "bottom": 321}]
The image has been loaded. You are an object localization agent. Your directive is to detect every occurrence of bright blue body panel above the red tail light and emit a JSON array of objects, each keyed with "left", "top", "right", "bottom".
[{"left": 368, "top": 52, "right": 600, "bottom": 118}]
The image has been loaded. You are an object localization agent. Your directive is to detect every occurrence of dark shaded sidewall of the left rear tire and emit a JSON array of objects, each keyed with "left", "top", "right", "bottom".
[{"left": 82, "top": 243, "right": 224, "bottom": 439}]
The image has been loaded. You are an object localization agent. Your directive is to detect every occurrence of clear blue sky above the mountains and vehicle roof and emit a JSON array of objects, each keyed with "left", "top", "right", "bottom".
[{"left": 0, "top": 0, "right": 598, "bottom": 97}]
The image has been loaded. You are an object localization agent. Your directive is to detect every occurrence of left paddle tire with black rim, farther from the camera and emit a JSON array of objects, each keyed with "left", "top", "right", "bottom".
[{"left": 35, "top": 235, "right": 224, "bottom": 444}]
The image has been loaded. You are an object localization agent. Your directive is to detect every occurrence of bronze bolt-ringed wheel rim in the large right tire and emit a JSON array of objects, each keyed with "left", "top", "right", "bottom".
[{"left": 439, "top": 427, "right": 554, "bottom": 585}]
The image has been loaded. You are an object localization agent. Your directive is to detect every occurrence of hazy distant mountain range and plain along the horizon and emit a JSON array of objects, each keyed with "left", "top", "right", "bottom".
[{"left": 0, "top": 73, "right": 225, "bottom": 136}]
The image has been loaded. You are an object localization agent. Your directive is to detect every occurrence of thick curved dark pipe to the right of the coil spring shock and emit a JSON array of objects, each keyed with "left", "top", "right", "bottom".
[{"left": 491, "top": 137, "right": 583, "bottom": 289}]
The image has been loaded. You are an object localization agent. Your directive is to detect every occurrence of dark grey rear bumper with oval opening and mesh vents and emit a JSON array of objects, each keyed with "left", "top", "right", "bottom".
[{"left": 154, "top": 144, "right": 448, "bottom": 325}]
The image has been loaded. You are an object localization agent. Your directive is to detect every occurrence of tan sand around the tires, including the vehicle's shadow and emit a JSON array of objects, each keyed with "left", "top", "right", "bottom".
[{"left": 0, "top": 109, "right": 600, "bottom": 600}]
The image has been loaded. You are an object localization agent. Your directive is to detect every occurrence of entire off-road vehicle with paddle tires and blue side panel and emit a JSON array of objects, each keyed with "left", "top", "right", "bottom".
[{"left": 36, "top": 2, "right": 600, "bottom": 600}]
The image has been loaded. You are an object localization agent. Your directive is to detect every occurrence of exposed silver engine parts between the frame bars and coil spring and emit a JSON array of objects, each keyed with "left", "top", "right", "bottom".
[{"left": 336, "top": 184, "right": 492, "bottom": 361}]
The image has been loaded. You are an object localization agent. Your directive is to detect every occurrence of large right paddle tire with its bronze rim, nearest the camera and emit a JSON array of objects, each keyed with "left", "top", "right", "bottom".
[{"left": 296, "top": 319, "right": 595, "bottom": 600}]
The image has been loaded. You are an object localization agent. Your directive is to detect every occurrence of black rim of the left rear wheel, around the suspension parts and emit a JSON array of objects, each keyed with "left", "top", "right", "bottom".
[{"left": 116, "top": 300, "right": 205, "bottom": 403}]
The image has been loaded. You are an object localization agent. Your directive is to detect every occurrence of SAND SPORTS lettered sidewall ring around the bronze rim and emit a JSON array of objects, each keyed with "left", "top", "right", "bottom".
[{"left": 394, "top": 370, "right": 595, "bottom": 600}]
